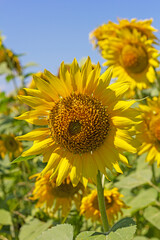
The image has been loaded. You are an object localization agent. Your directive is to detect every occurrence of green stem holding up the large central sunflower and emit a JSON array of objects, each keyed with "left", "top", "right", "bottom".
[{"left": 97, "top": 170, "right": 109, "bottom": 232}]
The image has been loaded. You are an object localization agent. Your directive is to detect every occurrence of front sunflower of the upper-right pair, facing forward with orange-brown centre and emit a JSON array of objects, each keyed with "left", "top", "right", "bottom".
[{"left": 102, "top": 29, "right": 159, "bottom": 96}]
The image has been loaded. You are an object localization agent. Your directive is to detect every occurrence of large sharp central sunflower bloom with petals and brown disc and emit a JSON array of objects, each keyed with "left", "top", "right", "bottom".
[{"left": 17, "top": 58, "right": 138, "bottom": 186}]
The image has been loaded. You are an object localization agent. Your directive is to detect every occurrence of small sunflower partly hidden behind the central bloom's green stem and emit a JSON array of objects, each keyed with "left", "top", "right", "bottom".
[{"left": 80, "top": 188, "right": 128, "bottom": 224}]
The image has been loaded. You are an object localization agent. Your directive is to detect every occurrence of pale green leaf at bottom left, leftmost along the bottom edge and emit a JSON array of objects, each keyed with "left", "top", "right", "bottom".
[{"left": 19, "top": 218, "right": 52, "bottom": 240}]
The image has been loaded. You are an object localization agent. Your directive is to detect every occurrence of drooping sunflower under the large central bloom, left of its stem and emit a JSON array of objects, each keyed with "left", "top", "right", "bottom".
[{"left": 30, "top": 170, "right": 86, "bottom": 217}]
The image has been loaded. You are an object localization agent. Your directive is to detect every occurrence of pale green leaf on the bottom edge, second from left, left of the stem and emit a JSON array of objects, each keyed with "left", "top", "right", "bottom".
[{"left": 35, "top": 224, "right": 73, "bottom": 240}]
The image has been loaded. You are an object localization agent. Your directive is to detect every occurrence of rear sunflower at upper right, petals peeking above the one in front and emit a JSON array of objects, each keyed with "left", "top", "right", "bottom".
[{"left": 89, "top": 18, "right": 157, "bottom": 48}]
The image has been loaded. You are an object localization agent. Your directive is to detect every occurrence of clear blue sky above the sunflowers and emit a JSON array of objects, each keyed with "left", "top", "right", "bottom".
[{"left": 0, "top": 0, "right": 160, "bottom": 90}]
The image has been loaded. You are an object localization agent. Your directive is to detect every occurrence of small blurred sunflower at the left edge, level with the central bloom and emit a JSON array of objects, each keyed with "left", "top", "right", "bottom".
[{"left": 0, "top": 134, "right": 23, "bottom": 160}]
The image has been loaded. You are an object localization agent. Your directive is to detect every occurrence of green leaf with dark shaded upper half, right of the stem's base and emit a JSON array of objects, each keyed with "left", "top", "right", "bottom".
[{"left": 106, "top": 217, "right": 136, "bottom": 240}]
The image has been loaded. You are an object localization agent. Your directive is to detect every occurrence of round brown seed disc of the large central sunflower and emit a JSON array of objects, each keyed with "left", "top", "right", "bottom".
[{"left": 49, "top": 93, "right": 109, "bottom": 154}]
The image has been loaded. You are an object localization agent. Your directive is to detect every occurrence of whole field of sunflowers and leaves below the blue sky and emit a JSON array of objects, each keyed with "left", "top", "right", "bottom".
[{"left": 0, "top": 19, "right": 160, "bottom": 240}]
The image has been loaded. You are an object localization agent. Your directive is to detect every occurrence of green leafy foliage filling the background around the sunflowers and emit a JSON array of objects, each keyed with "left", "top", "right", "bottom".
[{"left": 0, "top": 19, "right": 160, "bottom": 240}]
